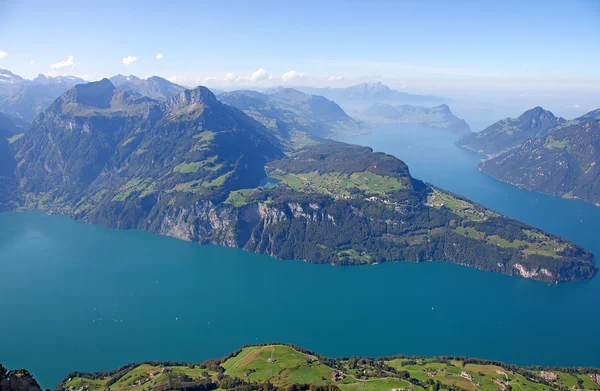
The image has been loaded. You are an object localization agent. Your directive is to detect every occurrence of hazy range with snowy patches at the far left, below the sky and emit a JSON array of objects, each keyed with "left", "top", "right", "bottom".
[{"left": 0, "top": 69, "right": 86, "bottom": 122}]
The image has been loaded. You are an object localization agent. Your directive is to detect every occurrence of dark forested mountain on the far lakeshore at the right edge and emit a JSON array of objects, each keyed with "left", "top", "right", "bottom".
[{"left": 474, "top": 108, "right": 600, "bottom": 206}]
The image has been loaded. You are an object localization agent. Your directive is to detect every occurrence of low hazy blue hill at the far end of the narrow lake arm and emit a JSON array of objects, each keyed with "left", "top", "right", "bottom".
[{"left": 364, "top": 103, "right": 471, "bottom": 133}]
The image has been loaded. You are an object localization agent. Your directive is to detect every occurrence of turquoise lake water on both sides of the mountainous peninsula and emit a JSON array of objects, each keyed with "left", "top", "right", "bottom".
[{"left": 0, "top": 126, "right": 600, "bottom": 388}]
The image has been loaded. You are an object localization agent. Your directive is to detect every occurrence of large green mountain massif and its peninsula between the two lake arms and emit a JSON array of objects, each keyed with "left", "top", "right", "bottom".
[{"left": 0, "top": 79, "right": 597, "bottom": 282}]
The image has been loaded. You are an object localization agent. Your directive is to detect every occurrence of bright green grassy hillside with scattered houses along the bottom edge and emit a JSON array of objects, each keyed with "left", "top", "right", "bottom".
[{"left": 48, "top": 343, "right": 600, "bottom": 391}]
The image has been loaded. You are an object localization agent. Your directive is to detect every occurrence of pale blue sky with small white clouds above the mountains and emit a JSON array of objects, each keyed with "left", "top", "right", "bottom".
[{"left": 0, "top": 0, "right": 600, "bottom": 94}]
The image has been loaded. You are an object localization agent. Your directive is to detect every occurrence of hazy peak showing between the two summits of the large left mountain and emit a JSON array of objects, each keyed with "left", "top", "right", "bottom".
[{"left": 110, "top": 75, "right": 186, "bottom": 102}]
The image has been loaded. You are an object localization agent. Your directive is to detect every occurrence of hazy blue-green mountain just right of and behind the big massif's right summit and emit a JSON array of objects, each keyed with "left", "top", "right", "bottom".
[{"left": 218, "top": 87, "right": 362, "bottom": 140}]
